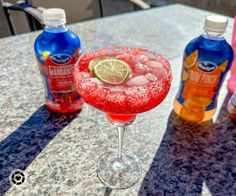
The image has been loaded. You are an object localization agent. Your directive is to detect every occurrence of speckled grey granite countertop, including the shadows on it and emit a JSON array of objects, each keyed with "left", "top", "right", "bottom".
[{"left": 0, "top": 5, "right": 236, "bottom": 196}]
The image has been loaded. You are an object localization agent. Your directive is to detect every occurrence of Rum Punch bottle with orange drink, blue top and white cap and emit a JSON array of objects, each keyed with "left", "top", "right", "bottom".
[{"left": 174, "top": 16, "right": 233, "bottom": 122}]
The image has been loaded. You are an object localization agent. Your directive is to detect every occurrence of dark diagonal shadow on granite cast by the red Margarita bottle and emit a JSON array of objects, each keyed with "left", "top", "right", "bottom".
[{"left": 0, "top": 105, "right": 78, "bottom": 195}]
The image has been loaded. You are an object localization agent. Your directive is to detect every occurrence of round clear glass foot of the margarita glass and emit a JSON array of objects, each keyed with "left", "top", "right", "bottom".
[{"left": 97, "top": 152, "right": 141, "bottom": 189}]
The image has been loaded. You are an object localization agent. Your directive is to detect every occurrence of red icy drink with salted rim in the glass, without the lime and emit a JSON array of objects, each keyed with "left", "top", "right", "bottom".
[{"left": 74, "top": 47, "right": 172, "bottom": 121}]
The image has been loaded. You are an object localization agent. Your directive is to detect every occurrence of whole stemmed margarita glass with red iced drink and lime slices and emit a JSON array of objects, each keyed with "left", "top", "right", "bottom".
[{"left": 74, "top": 46, "right": 172, "bottom": 188}]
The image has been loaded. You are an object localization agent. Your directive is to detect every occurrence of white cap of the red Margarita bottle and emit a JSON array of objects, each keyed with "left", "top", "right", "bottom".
[{"left": 43, "top": 8, "right": 66, "bottom": 26}]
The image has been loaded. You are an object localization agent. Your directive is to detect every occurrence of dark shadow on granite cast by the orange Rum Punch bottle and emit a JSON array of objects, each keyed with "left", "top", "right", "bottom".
[{"left": 139, "top": 95, "right": 236, "bottom": 196}]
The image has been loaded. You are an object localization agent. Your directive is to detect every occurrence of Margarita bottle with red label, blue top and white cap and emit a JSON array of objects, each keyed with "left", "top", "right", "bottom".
[{"left": 34, "top": 8, "right": 83, "bottom": 113}]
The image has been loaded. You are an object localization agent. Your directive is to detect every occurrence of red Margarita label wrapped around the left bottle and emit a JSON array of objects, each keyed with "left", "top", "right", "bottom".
[{"left": 38, "top": 48, "right": 80, "bottom": 104}]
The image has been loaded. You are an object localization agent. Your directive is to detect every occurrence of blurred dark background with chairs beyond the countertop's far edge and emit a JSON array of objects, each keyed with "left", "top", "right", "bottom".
[{"left": 0, "top": 0, "right": 236, "bottom": 38}]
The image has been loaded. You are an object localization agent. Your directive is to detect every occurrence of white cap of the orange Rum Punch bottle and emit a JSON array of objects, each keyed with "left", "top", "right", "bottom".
[{"left": 203, "top": 15, "right": 228, "bottom": 33}]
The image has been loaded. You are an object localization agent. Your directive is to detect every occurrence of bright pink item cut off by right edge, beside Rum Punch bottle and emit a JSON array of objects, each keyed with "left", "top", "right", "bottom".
[{"left": 227, "top": 16, "right": 236, "bottom": 93}]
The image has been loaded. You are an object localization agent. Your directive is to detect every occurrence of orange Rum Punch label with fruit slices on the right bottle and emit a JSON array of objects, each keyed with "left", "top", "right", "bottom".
[{"left": 177, "top": 50, "right": 228, "bottom": 113}]
